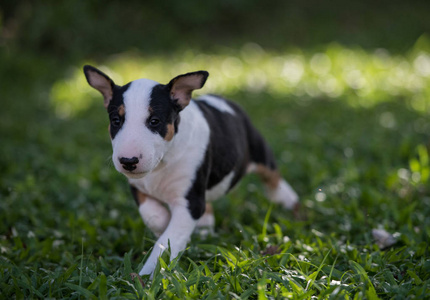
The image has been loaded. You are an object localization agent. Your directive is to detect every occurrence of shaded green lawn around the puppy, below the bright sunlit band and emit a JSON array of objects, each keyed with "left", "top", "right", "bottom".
[{"left": 0, "top": 48, "right": 430, "bottom": 299}]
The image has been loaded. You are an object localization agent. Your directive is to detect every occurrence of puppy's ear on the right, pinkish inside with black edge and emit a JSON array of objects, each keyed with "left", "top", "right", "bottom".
[{"left": 168, "top": 71, "right": 209, "bottom": 109}]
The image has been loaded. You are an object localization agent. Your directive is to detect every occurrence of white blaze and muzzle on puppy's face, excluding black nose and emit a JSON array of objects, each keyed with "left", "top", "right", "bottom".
[{"left": 112, "top": 79, "right": 167, "bottom": 178}]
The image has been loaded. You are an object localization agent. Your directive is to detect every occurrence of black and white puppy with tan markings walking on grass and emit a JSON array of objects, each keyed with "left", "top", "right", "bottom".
[{"left": 84, "top": 66, "right": 298, "bottom": 275}]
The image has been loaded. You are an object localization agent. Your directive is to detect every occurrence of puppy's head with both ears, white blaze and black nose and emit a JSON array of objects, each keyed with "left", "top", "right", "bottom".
[{"left": 84, "top": 66, "right": 209, "bottom": 178}]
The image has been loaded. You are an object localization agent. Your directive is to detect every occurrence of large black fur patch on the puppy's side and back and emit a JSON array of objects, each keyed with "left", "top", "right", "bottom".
[{"left": 186, "top": 100, "right": 276, "bottom": 219}]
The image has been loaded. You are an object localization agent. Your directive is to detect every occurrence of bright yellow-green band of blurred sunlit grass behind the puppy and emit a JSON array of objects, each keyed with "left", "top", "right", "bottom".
[{"left": 51, "top": 36, "right": 430, "bottom": 117}]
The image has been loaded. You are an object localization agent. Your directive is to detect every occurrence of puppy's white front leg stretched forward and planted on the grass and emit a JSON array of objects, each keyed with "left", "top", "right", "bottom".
[{"left": 139, "top": 199, "right": 196, "bottom": 277}]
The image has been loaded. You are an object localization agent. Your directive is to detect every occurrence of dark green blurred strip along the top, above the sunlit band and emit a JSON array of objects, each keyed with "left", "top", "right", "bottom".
[{"left": 1, "top": 0, "right": 429, "bottom": 59}]
